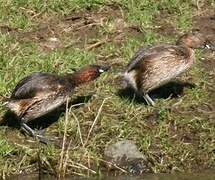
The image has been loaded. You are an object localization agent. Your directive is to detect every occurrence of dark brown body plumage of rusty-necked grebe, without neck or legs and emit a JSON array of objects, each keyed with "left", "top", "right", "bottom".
[{"left": 7, "top": 72, "right": 74, "bottom": 122}]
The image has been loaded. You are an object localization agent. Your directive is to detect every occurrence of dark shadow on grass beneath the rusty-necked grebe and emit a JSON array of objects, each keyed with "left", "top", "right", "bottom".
[{"left": 0, "top": 95, "right": 92, "bottom": 130}]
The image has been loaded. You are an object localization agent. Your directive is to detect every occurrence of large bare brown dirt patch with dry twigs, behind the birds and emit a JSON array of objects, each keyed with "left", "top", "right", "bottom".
[{"left": 0, "top": 6, "right": 142, "bottom": 51}]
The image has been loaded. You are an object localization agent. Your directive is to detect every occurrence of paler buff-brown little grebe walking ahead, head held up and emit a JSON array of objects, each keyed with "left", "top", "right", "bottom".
[{"left": 122, "top": 32, "right": 208, "bottom": 106}]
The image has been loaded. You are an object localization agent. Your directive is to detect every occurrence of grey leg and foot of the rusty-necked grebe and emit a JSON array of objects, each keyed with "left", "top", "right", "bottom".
[{"left": 21, "top": 122, "right": 48, "bottom": 144}]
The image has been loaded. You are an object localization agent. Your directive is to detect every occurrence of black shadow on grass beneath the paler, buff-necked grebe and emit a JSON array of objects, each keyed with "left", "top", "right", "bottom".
[{"left": 117, "top": 81, "right": 195, "bottom": 105}]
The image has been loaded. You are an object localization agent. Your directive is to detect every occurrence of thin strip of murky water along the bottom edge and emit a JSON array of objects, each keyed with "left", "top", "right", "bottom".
[{"left": 7, "top": 171, "right": 215, "bottom": 180}]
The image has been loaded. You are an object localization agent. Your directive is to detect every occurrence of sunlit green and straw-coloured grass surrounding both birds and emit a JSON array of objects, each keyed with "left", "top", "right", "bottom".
[{"left": 0, "top": 0, "right": 215, "bottom": 178}]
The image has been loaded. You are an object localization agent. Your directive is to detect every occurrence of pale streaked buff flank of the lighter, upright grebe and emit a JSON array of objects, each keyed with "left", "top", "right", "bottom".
[{"left": 139, "top": 46, "right": 193, "bottom": 91}]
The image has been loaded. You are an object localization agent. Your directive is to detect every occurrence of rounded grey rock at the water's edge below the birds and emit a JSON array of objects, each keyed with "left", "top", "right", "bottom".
[{"left": 104, "top": 140, "right": 150, "bottom": 174}]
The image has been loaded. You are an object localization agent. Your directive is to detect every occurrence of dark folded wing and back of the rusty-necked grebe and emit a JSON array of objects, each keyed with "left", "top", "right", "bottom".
[{"left": 11, "top": 72, "right": 72, "bottom": 99}]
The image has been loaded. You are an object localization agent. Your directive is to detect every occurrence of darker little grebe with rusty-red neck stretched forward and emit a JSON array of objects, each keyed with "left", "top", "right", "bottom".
[{"left": 5, "top": 65, "right": 109, "bottom": 141}]
